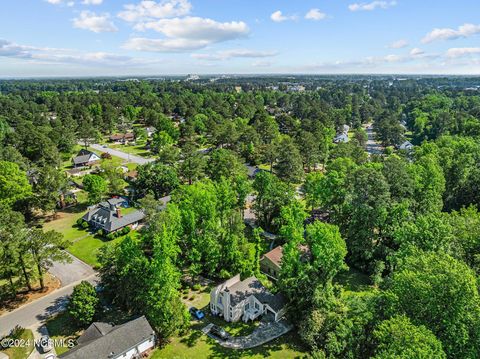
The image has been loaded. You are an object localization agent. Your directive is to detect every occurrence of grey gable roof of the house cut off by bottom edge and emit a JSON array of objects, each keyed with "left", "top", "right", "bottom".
[{"left": 60, "top": 316, "right": 154, "bottom": 359}]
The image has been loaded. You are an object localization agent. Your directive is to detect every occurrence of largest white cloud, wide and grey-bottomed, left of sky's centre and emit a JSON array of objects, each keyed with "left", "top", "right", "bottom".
[{"left": 123, "top": 16, "right": 250, "bottom": 52}]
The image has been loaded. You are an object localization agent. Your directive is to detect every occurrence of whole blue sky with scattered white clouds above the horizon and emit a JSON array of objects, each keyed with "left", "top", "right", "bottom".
[{"left": 0, "top": 0, "right": 480, "bottom": 77}]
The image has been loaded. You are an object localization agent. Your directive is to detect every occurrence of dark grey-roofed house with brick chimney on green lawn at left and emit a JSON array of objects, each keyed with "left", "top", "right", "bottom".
[{"left": 82, "top": 197, "right": 145, "bottom": 234}]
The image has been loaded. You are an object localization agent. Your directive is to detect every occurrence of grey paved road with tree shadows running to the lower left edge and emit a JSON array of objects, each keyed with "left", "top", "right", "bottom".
[{"left": 0, "top": 274, "right": 98, "bottom": 337}]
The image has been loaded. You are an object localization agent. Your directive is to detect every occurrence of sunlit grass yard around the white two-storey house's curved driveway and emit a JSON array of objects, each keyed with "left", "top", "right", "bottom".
[{"left": 151, "top": 287, "right": 307, "bottom": 359}]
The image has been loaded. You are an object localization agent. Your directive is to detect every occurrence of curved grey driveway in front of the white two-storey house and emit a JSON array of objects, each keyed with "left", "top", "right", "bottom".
[{"left": 205, "top": 320, "right": 293, "bottom": 349}]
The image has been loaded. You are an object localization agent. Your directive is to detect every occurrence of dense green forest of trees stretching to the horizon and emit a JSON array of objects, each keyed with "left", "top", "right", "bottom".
[{"left": 0, "top": 76, "right": 480, "bottom": 359}]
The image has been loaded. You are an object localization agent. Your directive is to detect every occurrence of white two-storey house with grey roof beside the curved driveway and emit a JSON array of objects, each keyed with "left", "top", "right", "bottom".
[{"left": 210, "top": 274, "right": 286, "bottom": 322}]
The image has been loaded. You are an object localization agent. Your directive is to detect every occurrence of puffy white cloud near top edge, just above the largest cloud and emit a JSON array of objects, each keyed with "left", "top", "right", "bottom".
[{"left": 118, "top": 0, "right": 192, "bottom": 22}]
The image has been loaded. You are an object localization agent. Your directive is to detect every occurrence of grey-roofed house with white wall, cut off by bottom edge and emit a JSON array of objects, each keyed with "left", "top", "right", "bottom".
[{"left": 59, "top": 316, "right": 155, "bottom": 359}]
